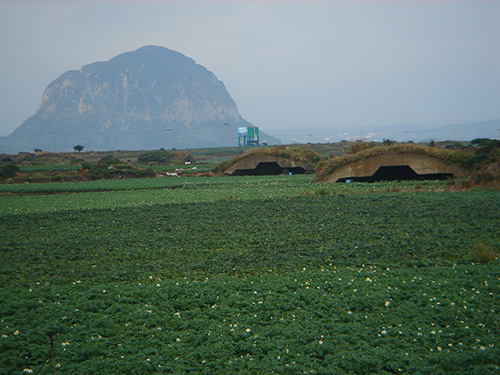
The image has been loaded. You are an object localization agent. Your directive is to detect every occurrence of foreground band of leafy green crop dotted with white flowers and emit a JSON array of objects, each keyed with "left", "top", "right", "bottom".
[{"left": 0, "top": 265, "right": 500, "bottom": 375}]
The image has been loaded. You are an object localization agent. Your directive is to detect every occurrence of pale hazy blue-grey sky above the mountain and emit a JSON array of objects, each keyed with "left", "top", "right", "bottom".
[{"left": 0, "top": 0, "right": 500, "bottom": 140}]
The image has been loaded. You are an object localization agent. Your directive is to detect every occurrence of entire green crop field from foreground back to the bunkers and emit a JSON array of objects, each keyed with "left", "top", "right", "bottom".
[{"left": 0, "top": 176, "right": 500, "bottom": 374}]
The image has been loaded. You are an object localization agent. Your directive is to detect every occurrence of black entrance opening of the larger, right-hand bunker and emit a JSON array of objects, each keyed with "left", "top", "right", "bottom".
[{"left": 336, "top": 165, "right": 453, "bottom": 182}]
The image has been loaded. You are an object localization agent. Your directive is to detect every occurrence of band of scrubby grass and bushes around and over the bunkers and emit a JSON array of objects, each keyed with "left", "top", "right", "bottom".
[{"left": 0, "top": 139, "right": 500, "bottom": 189}]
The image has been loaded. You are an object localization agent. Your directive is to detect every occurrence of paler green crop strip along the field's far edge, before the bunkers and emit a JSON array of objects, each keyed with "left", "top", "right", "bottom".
[{"left": 0, "top": 175, "right": 450, "bottom": 215}]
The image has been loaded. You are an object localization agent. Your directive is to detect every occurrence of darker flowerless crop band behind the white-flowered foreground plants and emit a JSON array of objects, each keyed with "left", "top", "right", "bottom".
[{"left": 0, "top": 192, "right": 500, "bottom": 282}]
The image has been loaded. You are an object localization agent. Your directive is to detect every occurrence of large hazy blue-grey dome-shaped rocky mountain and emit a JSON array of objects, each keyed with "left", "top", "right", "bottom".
[{"left": 2, "top": 46, "right": 280, "bottom": 152}]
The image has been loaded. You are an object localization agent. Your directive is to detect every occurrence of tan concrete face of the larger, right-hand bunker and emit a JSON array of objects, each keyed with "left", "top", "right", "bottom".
[{"left": 322, "top": 154, "right": 464, "bottom": 182}]
